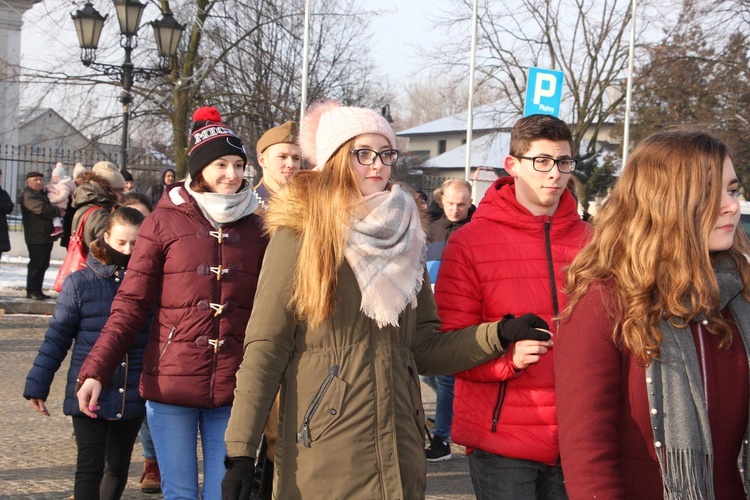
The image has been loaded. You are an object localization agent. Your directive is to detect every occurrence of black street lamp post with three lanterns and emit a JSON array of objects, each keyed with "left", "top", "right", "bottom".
[{"left": 71, "top": 0, "right": 185, "bottom": 175}]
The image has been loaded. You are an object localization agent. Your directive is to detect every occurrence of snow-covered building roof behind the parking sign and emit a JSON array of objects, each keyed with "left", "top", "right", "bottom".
[{"left": 396, "top": 101, "right": 521, "bottom": 137}]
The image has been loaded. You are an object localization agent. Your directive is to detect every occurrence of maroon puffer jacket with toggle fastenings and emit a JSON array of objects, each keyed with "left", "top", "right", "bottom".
[{"left": 78, "top": 185, "right": 268, "bottom": 408}]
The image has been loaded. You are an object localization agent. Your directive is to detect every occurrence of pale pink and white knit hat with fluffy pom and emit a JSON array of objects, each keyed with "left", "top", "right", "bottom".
[{"left": 299, "top": 101, "right": 396, "bottom": 170}]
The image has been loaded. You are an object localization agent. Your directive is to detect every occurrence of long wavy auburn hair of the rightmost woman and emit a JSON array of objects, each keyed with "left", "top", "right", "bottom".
[{"left": 563, "top": 129, "right": 750, "bottom": 366}]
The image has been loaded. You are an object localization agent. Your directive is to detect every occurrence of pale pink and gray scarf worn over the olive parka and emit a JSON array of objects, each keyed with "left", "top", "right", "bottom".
[{"left": 344, "top": 185, "right": 427, "bottom": 328}]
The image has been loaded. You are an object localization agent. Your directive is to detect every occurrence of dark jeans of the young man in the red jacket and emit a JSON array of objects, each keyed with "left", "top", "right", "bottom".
[{"left": 469, "top": 450, "right": 568, "bottom": 500}]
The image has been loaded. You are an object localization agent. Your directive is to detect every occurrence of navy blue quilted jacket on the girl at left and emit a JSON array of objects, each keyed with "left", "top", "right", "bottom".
[{"left": 23, "top": 255, "right": 151, "bottom": 420}]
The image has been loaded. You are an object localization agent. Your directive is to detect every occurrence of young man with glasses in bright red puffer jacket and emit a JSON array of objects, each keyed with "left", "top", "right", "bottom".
[{"left": 435, "top": 115, "right": 587, "bottom": 500}]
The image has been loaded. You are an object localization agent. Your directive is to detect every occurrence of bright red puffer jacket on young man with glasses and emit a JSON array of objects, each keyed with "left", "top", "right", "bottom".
[{"left": 435, "top": 177, "right": 588, "bottom": 465}]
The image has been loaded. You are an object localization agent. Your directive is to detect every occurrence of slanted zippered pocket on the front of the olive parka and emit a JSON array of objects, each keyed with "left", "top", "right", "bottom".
[{"left": 297, "top": 365, "right": 346, "bottom": 448}]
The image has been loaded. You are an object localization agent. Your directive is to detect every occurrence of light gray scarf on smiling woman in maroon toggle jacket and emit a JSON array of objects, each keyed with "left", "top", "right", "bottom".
[{"left": 181, "top": 174, "right": 258, "bottom": 229}]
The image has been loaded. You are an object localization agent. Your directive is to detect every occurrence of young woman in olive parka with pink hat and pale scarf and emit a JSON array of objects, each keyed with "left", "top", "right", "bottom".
[{"left": 222, "top": 102, "right": 549, "bottom": 499}]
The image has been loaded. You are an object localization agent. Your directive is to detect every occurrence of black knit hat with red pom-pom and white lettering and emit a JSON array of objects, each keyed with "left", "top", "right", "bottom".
[{"left": 188, "top": 106, "right": 247, "bottom": 179}]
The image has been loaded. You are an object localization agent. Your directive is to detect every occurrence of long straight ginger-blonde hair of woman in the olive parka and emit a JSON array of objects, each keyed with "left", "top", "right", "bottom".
[{"left": 264, "top": 139, "right": 363, "bottom": 327}]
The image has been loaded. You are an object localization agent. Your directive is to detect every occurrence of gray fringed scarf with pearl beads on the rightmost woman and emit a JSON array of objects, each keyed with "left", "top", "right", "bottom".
[{"left": 646, "top": 264, "right": 750, "bottom": 500}]
